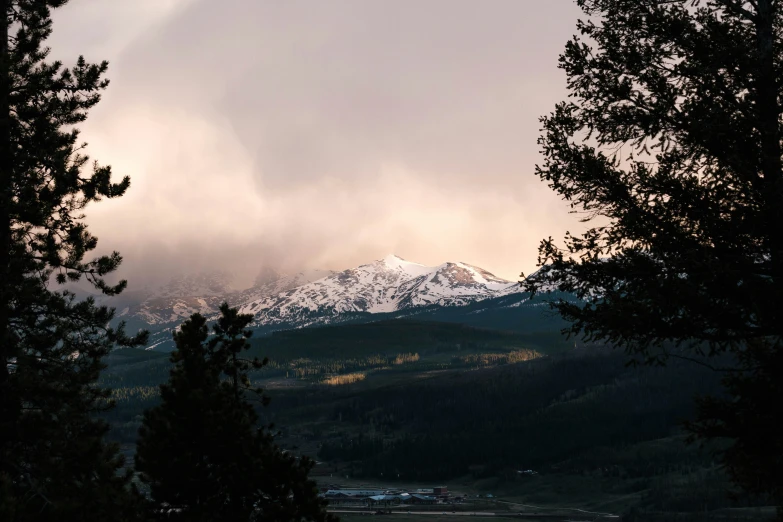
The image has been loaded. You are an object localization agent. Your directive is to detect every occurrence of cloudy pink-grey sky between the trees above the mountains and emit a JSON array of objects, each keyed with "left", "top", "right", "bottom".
[{"left": 50, "top": 0, "right": 579, "bottom": 286}]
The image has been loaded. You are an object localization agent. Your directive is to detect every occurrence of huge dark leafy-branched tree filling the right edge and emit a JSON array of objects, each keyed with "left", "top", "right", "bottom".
[{"left": 526, "top": 0, "right": 783, "bottom": 512}]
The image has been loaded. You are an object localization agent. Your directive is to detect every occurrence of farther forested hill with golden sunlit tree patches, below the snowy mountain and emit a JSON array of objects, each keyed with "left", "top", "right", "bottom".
[{"left": 101, "top": 320, "right": 552, "bottom": 442}]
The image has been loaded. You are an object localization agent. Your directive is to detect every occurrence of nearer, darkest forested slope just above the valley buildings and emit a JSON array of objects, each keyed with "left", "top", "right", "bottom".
[{"left": 314, "top": 354, "right": 717, "bottom": 480}]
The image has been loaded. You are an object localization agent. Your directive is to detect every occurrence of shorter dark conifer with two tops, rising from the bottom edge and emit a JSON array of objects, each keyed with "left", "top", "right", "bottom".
[{"left": 136, "top": 304, "right": 333, "bottom": 522}]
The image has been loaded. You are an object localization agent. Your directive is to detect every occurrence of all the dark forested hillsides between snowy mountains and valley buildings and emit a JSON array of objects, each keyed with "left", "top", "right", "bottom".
[{"left": 96, "top": 320, "right": 764, "bottom": 510}]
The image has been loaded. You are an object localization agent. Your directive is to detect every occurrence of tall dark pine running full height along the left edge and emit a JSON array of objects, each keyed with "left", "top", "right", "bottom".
[{"left": 0, "top": 0, "right": 149, "bottom": 521}]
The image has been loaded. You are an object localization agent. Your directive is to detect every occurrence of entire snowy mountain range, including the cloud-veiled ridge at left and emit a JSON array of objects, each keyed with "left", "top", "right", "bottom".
[{"left": 106, "top": 255, "right": 521, "bottom": 344}]
